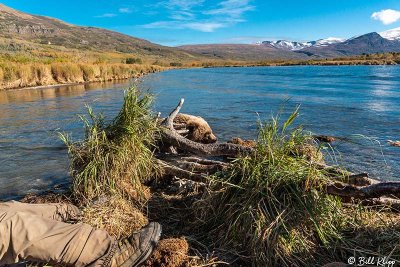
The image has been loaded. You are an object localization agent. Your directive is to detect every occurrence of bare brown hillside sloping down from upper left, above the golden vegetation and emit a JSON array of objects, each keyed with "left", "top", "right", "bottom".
[{"left": 0, "top": 4, "right": 202, "bottom": 60}]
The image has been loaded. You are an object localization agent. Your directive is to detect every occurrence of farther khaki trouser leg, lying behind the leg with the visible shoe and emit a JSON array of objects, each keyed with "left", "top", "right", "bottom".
[{"left": 0, "top": 201, "right": 80, "bottom": 222}]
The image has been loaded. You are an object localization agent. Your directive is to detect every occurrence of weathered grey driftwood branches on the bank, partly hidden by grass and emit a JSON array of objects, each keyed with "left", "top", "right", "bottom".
[{"left": 157, "top": 99, "right": 400, "bottom": 211}]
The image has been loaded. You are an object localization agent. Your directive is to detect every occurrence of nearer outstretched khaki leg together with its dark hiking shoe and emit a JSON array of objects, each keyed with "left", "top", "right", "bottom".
[{"left": 0, "top": 205, "right": 161, "bottom": 267}]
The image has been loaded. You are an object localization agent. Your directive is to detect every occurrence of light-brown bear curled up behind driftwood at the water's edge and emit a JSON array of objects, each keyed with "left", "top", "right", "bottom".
[{"left": 174, "top": 114, "right": 217, "bottom": 144}]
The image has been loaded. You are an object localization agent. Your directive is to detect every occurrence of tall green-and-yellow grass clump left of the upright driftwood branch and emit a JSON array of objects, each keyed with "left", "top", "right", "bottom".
[{"left": 62, "top": 87, "right": 158, "bottom": 203}]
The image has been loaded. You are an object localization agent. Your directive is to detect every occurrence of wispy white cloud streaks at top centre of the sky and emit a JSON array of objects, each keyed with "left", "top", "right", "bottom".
[{"left": 143, "top": 0, "right": 255, "bottom": 32}]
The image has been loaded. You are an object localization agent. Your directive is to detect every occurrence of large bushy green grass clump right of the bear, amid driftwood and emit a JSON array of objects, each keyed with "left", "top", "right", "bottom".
[{"left": 195, "top": 111, "right": 354, "bottom": 266}]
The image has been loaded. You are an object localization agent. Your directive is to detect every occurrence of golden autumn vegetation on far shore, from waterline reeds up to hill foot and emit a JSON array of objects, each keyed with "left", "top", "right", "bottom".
[{"left": 0, "top": 37, "right": 400, "bottom": 90}]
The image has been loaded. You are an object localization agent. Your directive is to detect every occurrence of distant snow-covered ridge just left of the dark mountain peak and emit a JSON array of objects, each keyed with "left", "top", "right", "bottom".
[{"left": 262, "top": 37, "right": 345, "bottom": 51}]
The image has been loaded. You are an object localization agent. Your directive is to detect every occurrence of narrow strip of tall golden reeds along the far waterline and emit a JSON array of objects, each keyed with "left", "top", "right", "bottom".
[{"left": 0, "top": 53, "right": 400, "bottom": 90}]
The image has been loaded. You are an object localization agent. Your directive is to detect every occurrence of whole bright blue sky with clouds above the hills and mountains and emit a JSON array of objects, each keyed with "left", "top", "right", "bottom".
[{"left": 1, "top": 0, "right": 400, "bottom": 46}]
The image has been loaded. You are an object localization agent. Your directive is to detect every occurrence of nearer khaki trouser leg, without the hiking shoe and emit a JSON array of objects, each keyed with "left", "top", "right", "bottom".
[{"left": 0, "top": 211, "right": 114, "bottom": 267}]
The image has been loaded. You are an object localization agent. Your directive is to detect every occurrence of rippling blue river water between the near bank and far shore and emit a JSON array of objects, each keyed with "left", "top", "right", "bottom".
[{"left": 0, "top": 66, "right": 400, "bottom": 199}]
